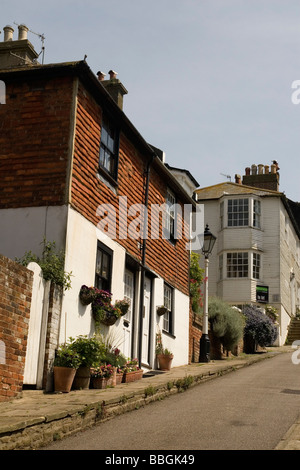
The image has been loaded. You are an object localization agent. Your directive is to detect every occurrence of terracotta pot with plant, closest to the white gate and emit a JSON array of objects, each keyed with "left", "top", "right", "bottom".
[{"left": 53, "top": 344, "right": 81, "bottom": 393}]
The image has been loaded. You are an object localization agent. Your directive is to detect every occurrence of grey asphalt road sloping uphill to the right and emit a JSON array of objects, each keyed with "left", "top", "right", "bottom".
[{"left": 45, "top": 354, "right": 300, "bottom": 451}]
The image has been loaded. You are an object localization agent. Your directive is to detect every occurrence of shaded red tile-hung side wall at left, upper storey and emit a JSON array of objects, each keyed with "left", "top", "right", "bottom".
[{"left": 0, "top": 74, "right": 73, "bottom": 208}]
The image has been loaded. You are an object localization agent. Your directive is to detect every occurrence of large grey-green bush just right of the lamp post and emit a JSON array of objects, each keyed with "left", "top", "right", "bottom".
[{"left": 208, "top": 297, "right": 245, "bottom": 351}]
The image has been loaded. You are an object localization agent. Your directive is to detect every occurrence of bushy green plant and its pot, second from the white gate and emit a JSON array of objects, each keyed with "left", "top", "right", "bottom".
[{"left": 70, "top": 335, "right": 103, "bottom": 390}]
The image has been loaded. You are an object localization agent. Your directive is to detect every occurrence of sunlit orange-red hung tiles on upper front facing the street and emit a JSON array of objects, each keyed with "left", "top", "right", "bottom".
[{"left": 71, "top": 83, "right": 189, "bottom": 295}]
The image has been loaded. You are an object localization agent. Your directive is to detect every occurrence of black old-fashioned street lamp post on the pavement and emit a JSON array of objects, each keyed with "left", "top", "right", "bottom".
[{"left": 199, "top": 225, "right": 217, "bottom": 362}]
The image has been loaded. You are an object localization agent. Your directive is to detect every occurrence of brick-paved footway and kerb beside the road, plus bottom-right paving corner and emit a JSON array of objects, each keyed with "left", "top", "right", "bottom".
[{"left": 0, "top": 346, "right": 300, "bottom": 450}]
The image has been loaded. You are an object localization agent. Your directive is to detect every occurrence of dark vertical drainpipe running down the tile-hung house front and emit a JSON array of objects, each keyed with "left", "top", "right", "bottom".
[{"left": 138, "top": 155, "right": 154, "bottom": 367}]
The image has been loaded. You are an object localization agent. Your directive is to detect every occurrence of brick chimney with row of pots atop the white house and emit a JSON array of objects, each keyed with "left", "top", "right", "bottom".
[{"left": 242, "top": 160, "right": 279, "bottom": 191}]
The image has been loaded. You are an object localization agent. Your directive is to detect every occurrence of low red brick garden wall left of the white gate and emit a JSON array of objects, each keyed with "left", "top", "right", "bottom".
[{"left": 0, "top": 255, "right": 33, "bottom": 401}]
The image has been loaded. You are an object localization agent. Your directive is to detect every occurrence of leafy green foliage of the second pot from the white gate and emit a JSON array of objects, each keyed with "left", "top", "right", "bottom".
[{"left": 70, "top": 335, "right": 103, "bottom": 367}]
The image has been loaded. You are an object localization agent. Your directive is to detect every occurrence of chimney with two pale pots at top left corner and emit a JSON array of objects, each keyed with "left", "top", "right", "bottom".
[{"left": 0, "top": 24, "right": 38, "bottom": 70}]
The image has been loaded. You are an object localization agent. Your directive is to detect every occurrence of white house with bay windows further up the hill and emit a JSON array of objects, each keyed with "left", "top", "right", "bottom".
[{"left": 196, "top": 163, "right": 300, "bottom": 345}]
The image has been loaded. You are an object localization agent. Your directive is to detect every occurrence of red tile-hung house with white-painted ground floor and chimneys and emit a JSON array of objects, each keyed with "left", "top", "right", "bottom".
[{"left": 0, "top": 26, "right": 196, "bottom": 388}]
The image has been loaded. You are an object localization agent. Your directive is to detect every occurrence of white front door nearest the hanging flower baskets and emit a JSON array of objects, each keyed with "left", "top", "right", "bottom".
[{"left": 123, "top": 269, "right": 134, "bottom": 358}]
